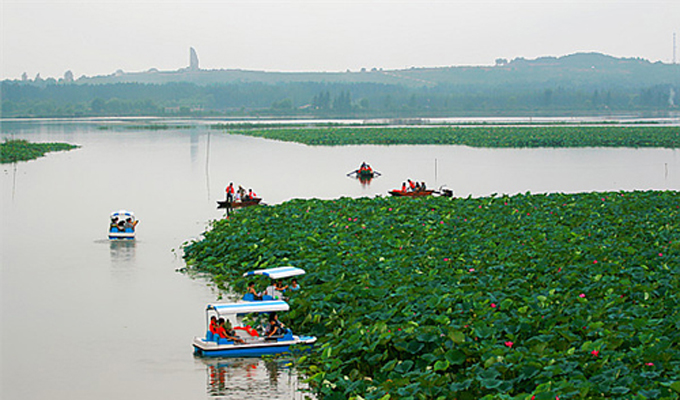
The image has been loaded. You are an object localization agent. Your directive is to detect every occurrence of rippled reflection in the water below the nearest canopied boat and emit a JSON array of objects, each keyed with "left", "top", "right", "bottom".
[{"left": 196, "top": 357, "right": 313, "bottom": 399}]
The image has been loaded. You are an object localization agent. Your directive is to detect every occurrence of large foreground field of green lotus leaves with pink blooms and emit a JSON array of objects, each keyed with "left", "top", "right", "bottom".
[{"left": 184, "top": 191, "right": 680, "bottom": 400}]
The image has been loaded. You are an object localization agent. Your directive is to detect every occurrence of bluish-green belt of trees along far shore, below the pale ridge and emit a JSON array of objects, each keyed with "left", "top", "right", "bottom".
[{"left": 1, "top": 81, "right": 680, "bottom": 117}]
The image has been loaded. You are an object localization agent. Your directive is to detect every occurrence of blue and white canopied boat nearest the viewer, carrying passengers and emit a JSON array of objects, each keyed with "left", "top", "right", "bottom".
[{"left": 193, "top": 300, "right": 316, "bottom": 357}]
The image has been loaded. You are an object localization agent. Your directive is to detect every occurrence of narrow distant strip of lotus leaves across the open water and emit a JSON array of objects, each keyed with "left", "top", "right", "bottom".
[{"left": 224, "top": 125, "right": 680, "bottom": 148}]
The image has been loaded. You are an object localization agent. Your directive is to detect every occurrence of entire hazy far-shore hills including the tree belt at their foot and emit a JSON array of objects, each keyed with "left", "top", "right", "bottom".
[{"left": 2, "top": 53, "right": 680, "bottom": 118}]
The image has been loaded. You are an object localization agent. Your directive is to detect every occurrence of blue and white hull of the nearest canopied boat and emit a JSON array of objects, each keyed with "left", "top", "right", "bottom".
[{"left": 193, "top": 336, "right": 316, "bottom": 357}]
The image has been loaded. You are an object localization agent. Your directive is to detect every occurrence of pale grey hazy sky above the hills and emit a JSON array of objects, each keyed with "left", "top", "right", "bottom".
[{"left": 0, "top": 0, "right": 680, "bottom": 79}]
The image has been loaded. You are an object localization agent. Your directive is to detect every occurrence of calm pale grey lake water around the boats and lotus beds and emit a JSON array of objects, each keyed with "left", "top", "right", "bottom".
[{"left": 0, "top": 121, "right": 680, "bottom": 399}]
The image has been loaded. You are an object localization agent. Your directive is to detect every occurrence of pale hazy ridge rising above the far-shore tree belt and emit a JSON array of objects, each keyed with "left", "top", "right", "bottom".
[{"left": 70, "top": 53, "right": 680, "bottom": 87}]
